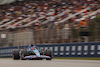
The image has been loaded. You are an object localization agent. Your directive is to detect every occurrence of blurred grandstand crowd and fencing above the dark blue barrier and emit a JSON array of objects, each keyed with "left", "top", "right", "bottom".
[{"left": 0, "top": 0, "right": 100, "bottom": 47}]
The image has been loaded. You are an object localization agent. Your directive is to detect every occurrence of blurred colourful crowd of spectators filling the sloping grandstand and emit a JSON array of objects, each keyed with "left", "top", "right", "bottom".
[{"left": 0, "top": 0, "right": 100, "bottom": 29}]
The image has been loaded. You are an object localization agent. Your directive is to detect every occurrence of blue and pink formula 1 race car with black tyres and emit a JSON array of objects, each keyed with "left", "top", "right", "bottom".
[{"left": 13, "top": 45, "right": 53, "bottom": 60}]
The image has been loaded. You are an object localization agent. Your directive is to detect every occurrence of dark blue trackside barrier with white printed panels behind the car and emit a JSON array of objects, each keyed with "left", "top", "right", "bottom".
[{"left": 0, "top": 42, "right": 100, "bottom": 57}]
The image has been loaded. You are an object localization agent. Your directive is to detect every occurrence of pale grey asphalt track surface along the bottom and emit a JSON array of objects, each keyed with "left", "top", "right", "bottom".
[{"left": 0, "top": 59, "right": 100, "bottom": 67}]
